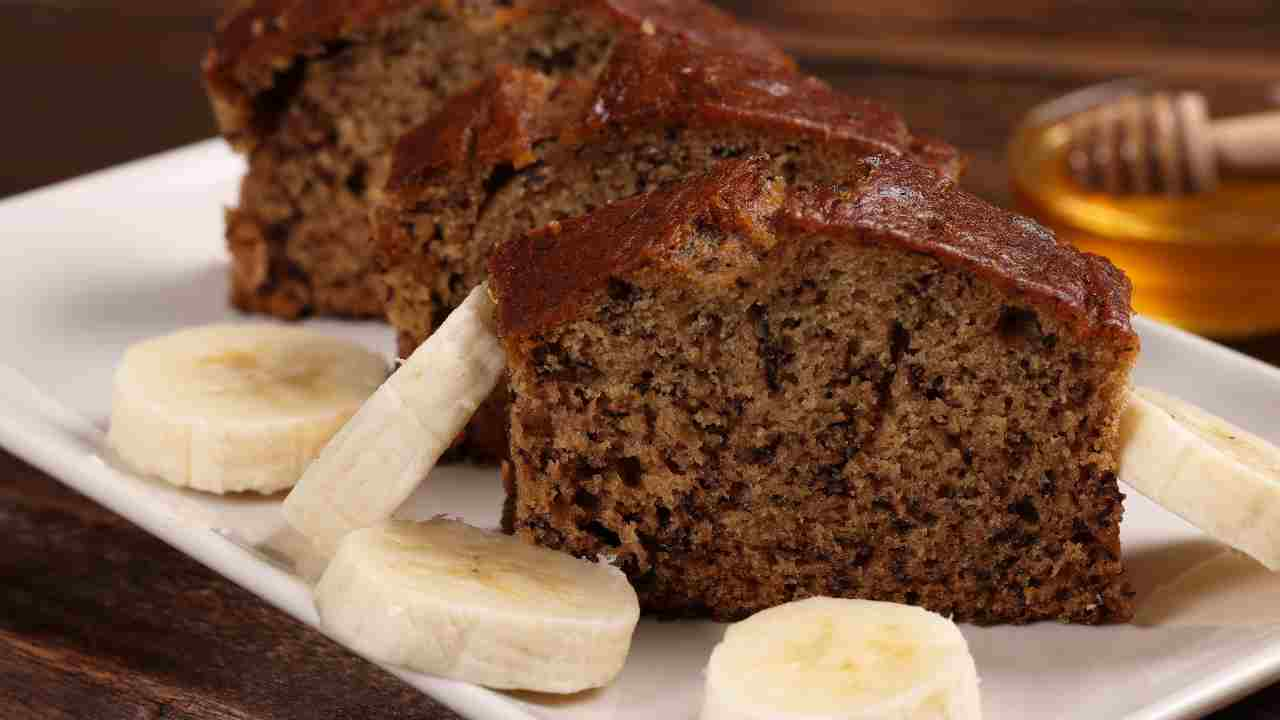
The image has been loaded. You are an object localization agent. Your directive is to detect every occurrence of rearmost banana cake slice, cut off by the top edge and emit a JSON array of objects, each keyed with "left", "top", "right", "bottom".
[{"left": 205, "top": 0, "right": 788, "bottom": 318}]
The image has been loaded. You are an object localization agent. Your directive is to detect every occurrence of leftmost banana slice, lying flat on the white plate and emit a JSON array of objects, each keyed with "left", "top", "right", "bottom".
[{"left": 108, "top": 325, "right": 387, "bottom": 493}]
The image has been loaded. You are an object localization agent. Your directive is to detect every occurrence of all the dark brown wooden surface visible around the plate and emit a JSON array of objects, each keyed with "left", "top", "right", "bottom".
[{"left": 0, "top": 0, "right": 1280, "bottom": 720}]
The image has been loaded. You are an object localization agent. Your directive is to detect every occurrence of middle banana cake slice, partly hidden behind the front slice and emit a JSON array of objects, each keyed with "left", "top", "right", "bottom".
[{"left": 374, "top": 35, "right": 960, "bottom": 459}]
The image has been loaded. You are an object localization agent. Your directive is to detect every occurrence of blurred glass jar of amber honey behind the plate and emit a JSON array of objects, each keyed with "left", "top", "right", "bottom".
[{"left": 1009, "top": 81, "right": 1280, "bottom": 340}]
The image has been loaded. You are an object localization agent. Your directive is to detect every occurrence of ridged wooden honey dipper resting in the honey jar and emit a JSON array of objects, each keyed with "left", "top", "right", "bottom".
[{"left": 1068, "top": 92, "right": 1280, "bottom": 195}]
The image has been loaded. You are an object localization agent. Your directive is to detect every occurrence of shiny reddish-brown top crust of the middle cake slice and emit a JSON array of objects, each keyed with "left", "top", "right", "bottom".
[{"left": 387, "top": 35, "right": 964, "bottom": 194}]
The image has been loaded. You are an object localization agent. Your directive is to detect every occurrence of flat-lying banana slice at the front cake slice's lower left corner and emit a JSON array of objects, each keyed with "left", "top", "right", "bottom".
[{"left": 316, "top": 519, "right": 640, "bottom": 693}]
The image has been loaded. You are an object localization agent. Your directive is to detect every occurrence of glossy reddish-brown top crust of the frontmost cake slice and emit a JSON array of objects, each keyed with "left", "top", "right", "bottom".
[{"left": 489, "top": 158, "right": 1137, "bottom": 343}]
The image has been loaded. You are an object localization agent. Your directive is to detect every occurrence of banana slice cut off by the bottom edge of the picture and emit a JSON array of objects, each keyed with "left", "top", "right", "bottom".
[{"left": 701, "top": 597, "right": 982, "bottom": 720}]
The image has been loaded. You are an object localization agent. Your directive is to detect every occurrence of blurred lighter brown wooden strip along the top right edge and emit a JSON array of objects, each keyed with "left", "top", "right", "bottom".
[{"left": 726, "top": 0, "right": 1277, "bottom": 82}]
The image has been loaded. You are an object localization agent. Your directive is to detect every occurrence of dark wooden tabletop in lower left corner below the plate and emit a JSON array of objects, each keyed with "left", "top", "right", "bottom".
[{"left": 0, "top": 452, "right": 453, "bottom": 720}]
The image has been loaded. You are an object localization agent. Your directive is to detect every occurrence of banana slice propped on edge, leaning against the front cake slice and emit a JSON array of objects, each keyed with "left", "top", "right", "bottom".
[{"left": 284, "top": 283, "right": 507, "bottom": 553}]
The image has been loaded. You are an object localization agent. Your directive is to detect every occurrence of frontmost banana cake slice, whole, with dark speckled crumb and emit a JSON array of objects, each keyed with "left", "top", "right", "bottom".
[{"left": 489, "top": 158, "right": 1139, "bottom": 623}]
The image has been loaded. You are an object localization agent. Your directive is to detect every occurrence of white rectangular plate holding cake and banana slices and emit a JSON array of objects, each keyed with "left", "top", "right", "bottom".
[{"left": 0, "top": 141, "right": 1280, "bottom": 720}]
